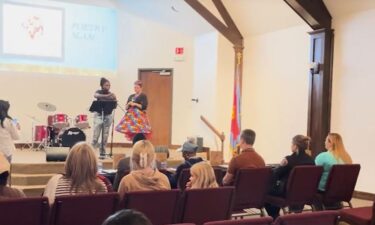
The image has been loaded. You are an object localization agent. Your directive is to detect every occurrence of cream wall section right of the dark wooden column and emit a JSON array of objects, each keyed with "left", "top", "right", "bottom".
[{"left": 331, "top": 9, "right": 375, "bottom": 193}]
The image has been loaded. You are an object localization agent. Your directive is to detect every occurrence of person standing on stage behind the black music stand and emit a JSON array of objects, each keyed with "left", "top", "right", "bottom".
[{"left": 92, "top": 77, "right": 116, "bottom": 156}]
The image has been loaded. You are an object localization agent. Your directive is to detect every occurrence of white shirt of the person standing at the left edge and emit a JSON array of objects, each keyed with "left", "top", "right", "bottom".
[{"left": 0, "top": 118, "right": 20, "bottom": 156}]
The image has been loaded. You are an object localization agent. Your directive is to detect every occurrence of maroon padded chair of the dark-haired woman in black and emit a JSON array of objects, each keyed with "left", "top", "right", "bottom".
[{"left": 266, "top": 166, "right": 323, "bottom": 214}]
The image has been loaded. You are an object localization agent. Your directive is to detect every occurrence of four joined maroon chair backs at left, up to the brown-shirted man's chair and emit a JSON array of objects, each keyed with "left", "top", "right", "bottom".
[{"left": 0, "top": 187, "right": 234, "bottom": 225}]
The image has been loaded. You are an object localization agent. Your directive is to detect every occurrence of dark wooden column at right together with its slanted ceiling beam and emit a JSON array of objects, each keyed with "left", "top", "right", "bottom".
[{"left": 284, "top": 0, "right": 333, "bottom": 156}]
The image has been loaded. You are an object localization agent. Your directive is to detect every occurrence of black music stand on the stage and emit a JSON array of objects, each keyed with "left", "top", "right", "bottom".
[{"left": 89, "top": 100, "right": 117, "bottom": 159}]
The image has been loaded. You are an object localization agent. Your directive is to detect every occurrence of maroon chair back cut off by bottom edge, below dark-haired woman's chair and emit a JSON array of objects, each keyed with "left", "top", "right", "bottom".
[{"left": 274, "top": 211, "right": 339, "bottom": 225}]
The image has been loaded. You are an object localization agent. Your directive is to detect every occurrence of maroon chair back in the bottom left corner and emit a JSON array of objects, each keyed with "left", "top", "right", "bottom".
[{"left": 0, "top": 197, "right": 49, "bottom": 225}]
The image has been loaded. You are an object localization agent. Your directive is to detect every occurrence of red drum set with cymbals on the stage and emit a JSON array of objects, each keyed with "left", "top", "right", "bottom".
[{"left": 32, "top": 102, "right": 90, "bottom": 149}]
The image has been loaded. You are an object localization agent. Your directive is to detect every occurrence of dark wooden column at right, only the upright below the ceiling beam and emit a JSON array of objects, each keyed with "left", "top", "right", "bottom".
[{"left": 307, "top": 28, "right": 333, "bottom": 156}]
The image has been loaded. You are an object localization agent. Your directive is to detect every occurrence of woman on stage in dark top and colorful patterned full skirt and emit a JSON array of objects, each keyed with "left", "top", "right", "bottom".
[{"left": 116, "top": 81, "right": 151, "bottom": 141}]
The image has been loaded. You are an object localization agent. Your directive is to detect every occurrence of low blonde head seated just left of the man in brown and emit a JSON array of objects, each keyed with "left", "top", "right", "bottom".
[{"left": 186, "top": 162, "right": 219, "bottom": 189}]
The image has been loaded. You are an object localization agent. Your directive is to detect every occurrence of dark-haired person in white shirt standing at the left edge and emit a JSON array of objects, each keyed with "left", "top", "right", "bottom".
[{"left": 0, "top": 100, "right": 20, "bottom": 163}]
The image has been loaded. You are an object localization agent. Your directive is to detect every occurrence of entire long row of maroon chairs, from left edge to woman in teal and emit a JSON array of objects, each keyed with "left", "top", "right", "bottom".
[{"left": 0, "top": 165, "right": 359, "bottom": 225}]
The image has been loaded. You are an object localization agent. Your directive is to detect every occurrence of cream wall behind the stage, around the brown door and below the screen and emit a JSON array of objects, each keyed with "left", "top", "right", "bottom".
[{"left": 0, "top": 1, "right": 194, "bottom": 144}]
